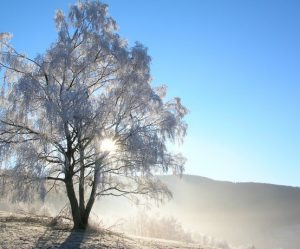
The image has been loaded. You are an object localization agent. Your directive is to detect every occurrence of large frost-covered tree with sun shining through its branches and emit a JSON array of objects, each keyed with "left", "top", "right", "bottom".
[{"left": 0, "top": 1, "right": 187, "bottom": 229}]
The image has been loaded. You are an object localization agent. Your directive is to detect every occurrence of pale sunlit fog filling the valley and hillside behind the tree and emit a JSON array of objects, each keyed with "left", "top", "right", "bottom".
[{"left": 1, "top": 176, "right": 300, "bottom": 249}]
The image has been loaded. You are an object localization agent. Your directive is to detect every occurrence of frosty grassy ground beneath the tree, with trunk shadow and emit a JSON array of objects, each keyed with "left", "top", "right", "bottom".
[{"left": 0, "top": 212, "right": 208, "bottom": 249}]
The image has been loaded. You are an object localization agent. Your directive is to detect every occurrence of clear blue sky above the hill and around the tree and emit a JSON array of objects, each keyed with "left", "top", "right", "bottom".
[{"left": 0, "top": 0, "right": 300, "bottom": 186}]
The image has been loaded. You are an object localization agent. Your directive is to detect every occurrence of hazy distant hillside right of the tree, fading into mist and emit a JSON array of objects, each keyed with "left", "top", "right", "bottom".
[{"left": 161, "top": 175, "right": 300, "bottom": 249}]
